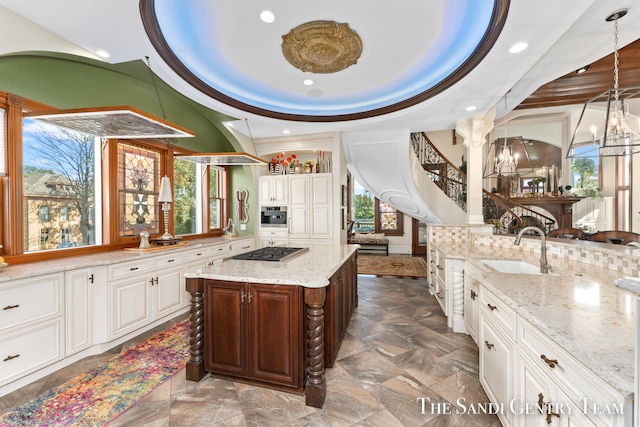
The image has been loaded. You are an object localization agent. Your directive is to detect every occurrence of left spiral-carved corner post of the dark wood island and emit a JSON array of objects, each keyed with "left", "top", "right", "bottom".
[{"left": 186, "top": 278, "right": 205, "bottom": 381}]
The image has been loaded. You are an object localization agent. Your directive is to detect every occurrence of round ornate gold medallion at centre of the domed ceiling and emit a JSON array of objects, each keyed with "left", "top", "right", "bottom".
[{"left": 282, "top": 21, "right": 362, "bottom": 74}]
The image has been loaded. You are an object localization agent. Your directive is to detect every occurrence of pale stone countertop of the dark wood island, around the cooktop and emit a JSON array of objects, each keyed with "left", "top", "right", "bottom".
[{"left": 185, "top": 244, "right": 359, "bottom": 288}]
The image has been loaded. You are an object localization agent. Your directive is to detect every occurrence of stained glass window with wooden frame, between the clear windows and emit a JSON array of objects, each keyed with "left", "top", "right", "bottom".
[{"left": 118, "top": 144, "right": 161, "bottom": 237}]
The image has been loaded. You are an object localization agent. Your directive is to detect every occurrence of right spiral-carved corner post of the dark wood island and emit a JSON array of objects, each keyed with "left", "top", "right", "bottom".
[{"left": 304, "top": 288, "right": 327, "bottom": 408}]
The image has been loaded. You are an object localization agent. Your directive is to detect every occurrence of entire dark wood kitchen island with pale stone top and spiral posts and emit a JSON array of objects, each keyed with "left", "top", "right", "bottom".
[{"left": 185, "top": 244, "right": 358, "bottom": 408}]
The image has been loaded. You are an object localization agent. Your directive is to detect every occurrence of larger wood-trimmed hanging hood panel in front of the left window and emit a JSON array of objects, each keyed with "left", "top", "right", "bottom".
[{"left": 24, "top": 106, "right": 195, "bottom": 139}]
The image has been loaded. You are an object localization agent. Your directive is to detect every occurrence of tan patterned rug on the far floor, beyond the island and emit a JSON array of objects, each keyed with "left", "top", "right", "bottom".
[{"left": 358, "top": 255, "right": 427, "bottom": 279}]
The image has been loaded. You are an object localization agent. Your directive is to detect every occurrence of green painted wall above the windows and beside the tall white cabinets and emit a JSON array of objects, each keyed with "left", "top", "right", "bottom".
[{"left": 0, "top": 52, "right": 257, "bottom": 235}]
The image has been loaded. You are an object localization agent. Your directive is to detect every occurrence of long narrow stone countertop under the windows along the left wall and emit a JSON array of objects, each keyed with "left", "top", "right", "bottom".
[{"left": 0, "top": 236, "right": 255, "bottom": 285}]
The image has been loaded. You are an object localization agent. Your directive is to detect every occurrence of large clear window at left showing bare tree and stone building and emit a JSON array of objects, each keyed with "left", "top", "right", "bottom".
[{"left": 22, "top": 119, "right": 100, "bottom": 252}]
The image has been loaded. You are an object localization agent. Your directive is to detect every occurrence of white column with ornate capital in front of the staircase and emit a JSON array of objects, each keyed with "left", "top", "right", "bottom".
[{"left": 456, "top": 113, "right": 495, "bottom": 224}]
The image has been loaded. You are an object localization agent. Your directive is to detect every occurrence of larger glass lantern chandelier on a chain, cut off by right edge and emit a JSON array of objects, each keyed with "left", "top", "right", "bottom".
[{"left": 567, "top": 9, "right": 640, "bottom": 158}]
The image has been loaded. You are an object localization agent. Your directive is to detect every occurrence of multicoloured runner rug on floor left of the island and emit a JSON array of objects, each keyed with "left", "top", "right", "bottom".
[{"left": 0, "top": 321, "right": 189, "bottom": 427}]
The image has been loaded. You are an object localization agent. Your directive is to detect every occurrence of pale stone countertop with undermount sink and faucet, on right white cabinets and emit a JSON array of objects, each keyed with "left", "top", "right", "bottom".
[{"left": 436, "top": 244, "right": 640, "bottom": 397}]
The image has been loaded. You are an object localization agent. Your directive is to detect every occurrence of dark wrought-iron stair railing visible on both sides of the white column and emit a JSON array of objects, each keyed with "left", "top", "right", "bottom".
[{"left": 411, "top": 132, "right": 555, "bottom": 234}]
